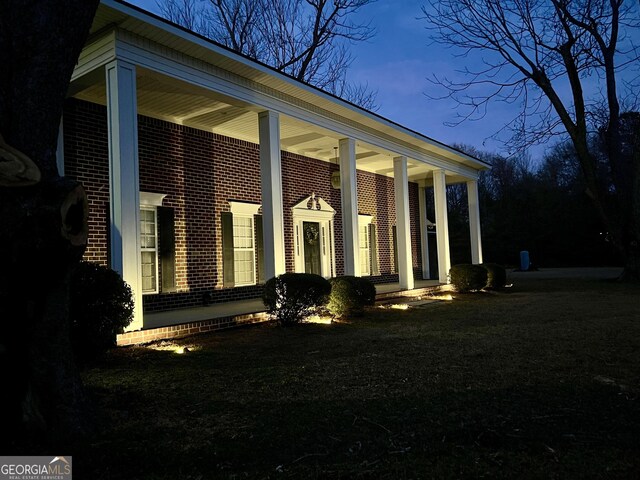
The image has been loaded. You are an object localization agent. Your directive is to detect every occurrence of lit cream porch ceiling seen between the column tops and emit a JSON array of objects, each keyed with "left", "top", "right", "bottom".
[{"left": 72, "top": 68, "right": 456, "bottom": 183}]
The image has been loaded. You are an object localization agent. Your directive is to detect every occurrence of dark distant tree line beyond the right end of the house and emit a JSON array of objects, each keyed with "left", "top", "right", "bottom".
[{"left": 438, "top": 137, "right": 622, "bottom": 267}]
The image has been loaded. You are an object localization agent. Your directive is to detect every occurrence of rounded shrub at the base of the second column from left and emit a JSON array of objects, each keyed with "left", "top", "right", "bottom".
[{"left": 262, "top": 273, "right": 331, "bottom": 326}]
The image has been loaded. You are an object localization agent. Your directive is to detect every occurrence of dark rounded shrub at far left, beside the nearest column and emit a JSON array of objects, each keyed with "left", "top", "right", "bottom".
[{"left": 69, "top": 262, "right": 133, "bottom": 362}]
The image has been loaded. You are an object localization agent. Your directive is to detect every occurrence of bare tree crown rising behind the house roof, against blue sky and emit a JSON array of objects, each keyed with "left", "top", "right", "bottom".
[{"left": 158, "top": 0, "right": 376, "bottom": 110}]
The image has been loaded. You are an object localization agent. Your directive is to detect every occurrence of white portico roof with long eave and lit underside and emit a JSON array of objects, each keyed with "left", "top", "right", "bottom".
[{"left": 69, "top": 0, "right": 489, "bottom": 183}]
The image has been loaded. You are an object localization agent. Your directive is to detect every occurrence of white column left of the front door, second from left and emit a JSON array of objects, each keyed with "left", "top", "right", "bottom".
[{"left": 258, "top": 111, "right": 286, "bottom": 279}]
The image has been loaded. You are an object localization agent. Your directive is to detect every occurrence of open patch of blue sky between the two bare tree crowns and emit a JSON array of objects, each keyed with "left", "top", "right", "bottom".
[{"left": 349, "top": 0, "right": 514, "bottom": 151}]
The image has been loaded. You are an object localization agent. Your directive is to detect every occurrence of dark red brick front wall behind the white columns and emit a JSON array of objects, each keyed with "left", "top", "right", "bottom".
[{"left": 64, "top": 100, "right": 420, "bottom": 311}]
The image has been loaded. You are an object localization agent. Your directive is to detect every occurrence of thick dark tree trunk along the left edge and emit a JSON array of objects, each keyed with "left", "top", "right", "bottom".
[{"left": 0, "top": 0, "right": 98, "bottom": 445}]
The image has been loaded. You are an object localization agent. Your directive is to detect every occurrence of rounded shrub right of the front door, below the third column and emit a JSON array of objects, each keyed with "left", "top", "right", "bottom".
[{"left": 327, "top": 275, "right": 376, "bottom": 317}]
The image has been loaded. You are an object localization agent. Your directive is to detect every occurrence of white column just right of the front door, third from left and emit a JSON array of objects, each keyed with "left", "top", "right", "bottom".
[{"left": 339, "top": 138, "right": 360, "bottom": 276}]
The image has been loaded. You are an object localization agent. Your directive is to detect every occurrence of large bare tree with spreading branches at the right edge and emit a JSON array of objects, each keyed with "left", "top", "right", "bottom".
[{"left": 422, "top": 0, "right": 640, "bottom": 279}]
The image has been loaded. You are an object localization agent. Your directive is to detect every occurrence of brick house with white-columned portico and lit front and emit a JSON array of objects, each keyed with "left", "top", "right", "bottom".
[{"left": 58, "top": 0, "right": 488, "bottom": 330}]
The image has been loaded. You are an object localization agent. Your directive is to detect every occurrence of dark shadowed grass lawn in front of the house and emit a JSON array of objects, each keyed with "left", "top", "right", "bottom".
[{"left": 73, "top": 275, "right": 640, "bottom": 479}]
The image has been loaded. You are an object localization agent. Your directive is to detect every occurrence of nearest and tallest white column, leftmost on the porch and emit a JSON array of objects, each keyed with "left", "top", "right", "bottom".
[{"left": 105, "top": 60, "right": 143, "bottom": 330}]
